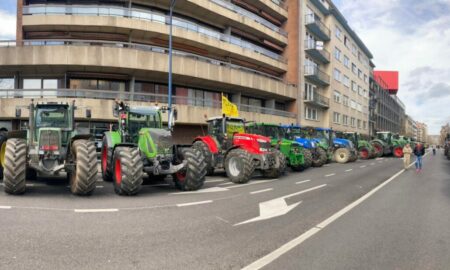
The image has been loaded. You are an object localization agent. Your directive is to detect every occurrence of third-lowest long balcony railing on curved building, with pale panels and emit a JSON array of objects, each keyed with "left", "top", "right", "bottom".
[{"left": 23, "top": 5, "right": 286, "bottom": 63}]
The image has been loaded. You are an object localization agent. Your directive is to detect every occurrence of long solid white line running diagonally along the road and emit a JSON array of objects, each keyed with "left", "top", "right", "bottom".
[{"left": 242, "top": 170, "right": 405, "bottom": 270}]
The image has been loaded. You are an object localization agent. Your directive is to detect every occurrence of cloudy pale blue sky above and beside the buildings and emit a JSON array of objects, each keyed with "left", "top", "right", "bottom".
[{"left": 0, "top": 0, "right": 450, "bottom": 134}]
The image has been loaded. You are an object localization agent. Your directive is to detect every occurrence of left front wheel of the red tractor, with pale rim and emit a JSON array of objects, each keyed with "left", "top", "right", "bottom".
[{"left": 225, "top": 148, "right": 255, "bottom": 184}]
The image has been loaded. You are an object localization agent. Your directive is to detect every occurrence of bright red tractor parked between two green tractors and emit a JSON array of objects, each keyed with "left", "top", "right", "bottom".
[{"left": 193, "top": 116, "right": 286, "bottom": 183}]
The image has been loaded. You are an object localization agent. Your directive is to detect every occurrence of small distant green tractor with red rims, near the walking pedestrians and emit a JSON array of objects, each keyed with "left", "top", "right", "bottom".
[{"left": 370, "top": 131, "right": 407, "bottom": 158}]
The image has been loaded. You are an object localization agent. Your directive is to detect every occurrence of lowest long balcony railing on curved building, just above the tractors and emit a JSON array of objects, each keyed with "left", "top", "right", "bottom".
[{"left": 0, "top": 89, "right": 296, "bottom": 118}]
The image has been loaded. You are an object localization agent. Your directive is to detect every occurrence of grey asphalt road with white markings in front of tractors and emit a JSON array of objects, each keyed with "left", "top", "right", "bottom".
[{"left": 0, "top": 153, "right": 450, "bottom": 269}]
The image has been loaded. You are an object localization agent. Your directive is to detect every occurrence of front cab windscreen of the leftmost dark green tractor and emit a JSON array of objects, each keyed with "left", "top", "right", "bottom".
[{"left": 36, "top": 106, "right": 69, "bottom": 128}]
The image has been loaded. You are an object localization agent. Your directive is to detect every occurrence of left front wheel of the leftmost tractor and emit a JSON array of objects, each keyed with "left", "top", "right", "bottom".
[{"left": 3, "top": 139, "right": 27, "bottom": 195}]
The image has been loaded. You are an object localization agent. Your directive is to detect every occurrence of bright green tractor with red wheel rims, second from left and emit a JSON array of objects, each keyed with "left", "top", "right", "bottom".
[{"left": 101, "top": 102, "right": 206, "bottom": 195}]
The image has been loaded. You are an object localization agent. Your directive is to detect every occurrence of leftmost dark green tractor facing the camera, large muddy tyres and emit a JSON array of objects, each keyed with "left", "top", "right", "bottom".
[{"left": 0, "top": 102, "right": 97, "bottom": 195}]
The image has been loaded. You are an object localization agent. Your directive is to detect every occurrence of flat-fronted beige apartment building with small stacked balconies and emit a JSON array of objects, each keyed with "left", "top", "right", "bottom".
[{"left": 301, "top": 0, "right": 372, "bottom": 134}]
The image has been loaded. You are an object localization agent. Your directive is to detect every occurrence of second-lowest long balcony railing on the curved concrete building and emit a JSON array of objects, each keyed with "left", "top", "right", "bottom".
[{"left": 0, "top": 39, "right": 284, "bottom": 82}]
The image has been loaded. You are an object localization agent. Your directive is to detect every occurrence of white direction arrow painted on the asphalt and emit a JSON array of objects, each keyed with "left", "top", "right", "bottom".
[{"left": 233, "top": 184, "right": 326, "bottom": 226}]
